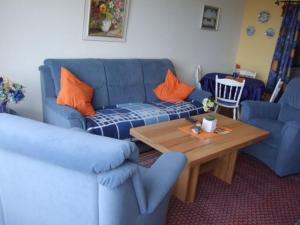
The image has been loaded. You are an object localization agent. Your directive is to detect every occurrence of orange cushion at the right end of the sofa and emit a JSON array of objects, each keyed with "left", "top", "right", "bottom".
[{"left": 153, "top": 70, "right": 194, "bottom": 102}]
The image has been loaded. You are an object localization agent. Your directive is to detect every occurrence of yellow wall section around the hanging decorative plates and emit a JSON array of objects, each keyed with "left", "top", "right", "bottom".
[{"left": 236, "top": 0, "right": 282, "bottom": 81}]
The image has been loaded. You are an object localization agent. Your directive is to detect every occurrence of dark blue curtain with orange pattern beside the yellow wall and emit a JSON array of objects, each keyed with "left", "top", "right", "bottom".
[{"left": 267, "top": 4, "right": 300, "bottom": 92}]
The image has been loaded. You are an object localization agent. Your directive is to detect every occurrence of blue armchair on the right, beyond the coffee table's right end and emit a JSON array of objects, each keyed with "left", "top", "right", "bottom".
[{"left": 241, "top": 78, "right": 300, "bottom": 176}]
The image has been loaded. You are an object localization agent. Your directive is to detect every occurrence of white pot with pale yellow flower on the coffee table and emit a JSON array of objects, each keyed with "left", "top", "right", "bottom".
[{"left": 202, "top": 98, "right": 217, "bottom": 132}]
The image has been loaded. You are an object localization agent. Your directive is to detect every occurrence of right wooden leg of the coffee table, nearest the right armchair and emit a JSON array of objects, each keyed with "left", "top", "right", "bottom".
[{"left": 213, "top": 151, "right": 238, "bottom": 184}]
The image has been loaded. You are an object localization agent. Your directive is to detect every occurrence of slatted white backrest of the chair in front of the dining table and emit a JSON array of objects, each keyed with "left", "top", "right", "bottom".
[{"left": 215, "top": 75, "right": 245, "bottom": 107}]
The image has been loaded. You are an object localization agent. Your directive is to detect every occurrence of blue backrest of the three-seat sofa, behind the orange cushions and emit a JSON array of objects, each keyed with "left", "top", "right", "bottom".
[{"left": 43, "top": 59, "right": 175, "bottom": 109}]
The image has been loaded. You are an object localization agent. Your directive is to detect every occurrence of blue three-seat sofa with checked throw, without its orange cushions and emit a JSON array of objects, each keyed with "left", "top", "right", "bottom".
[{"left": 39, "top": 59, "right": 211, "bottom": 139}]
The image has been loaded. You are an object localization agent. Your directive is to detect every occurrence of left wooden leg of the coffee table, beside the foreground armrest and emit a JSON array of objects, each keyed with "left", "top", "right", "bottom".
[{"left": 174, "top": 165, "right": 200, "bottom": 202}]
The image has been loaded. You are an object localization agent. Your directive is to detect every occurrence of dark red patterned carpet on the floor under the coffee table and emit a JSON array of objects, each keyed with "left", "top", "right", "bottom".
[{"left": 141, "top": 151, "right": 300, "bottom": 225}]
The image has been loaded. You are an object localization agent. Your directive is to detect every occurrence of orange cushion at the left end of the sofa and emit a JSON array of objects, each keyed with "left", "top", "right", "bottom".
[{"left": 56, "top": 67, "right": 96, "bottom": 116}]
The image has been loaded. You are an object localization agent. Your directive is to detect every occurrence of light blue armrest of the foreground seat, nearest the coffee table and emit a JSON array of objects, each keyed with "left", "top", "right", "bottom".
[{"left": 142, "top": 152, "right": 186, "bottom": 213}]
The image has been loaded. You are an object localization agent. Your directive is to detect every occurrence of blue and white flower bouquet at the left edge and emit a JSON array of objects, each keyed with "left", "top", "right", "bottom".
[{"left": 0, "top": 77, "right": 25, "bottom": 113}]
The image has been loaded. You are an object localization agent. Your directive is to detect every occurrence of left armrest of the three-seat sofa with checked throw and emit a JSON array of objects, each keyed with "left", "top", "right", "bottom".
[{"left": 44, "top": 97, "right": 85, "bottom": 129}]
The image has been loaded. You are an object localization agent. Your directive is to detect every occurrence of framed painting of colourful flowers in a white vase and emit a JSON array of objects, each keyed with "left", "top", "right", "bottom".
[{"left": 83, "top": 0, "right": 129, "bottom": 41}]
